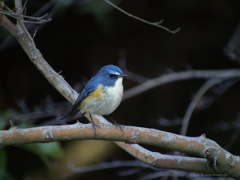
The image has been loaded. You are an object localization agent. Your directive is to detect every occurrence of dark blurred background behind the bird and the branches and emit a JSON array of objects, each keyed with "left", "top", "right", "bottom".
[{"left": 0, "top": 0, "right": 240, "bottom": 179}]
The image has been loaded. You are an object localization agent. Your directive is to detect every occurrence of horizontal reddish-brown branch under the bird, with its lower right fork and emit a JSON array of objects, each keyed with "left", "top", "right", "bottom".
[{"left": 0, "top": 123, "right": 240, "bottom": 178}]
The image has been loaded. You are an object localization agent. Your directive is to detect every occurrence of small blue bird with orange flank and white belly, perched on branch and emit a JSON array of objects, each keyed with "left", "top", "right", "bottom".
[{"left": 61, "top": 65, "right": 127, "bottom": 125}]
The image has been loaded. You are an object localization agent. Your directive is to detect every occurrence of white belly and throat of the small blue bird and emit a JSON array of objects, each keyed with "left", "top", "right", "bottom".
[{"left": 82, "top": 78, "right": 123, "bottom": 115}]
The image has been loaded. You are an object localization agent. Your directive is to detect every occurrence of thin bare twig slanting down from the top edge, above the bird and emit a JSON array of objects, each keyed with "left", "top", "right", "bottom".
[{"left": 104, "top": 0, "right": 180, "bottom": 34}]
